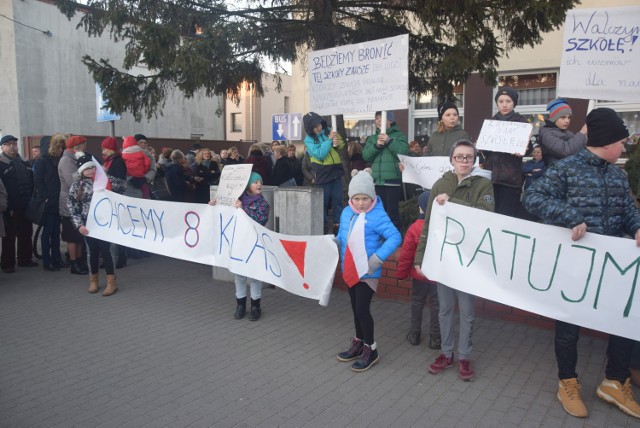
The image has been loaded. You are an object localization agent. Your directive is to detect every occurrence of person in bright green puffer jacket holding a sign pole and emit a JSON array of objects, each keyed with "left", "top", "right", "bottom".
[{"left": 362, "top": 111, "right": 409, "bottom": 229}]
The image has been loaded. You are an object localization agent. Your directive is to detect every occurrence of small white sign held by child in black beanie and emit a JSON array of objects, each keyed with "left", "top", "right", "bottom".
[{"left": 476, "top": 119, "right": 533, "bottom": 155}]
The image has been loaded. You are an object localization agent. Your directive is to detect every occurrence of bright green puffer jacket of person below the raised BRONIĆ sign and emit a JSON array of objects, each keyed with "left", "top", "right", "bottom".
[{"left": 362, "top": 123, "right": 409, "bottom": 185}]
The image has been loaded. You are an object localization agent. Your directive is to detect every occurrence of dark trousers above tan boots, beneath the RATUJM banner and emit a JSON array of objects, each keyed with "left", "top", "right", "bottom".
[{"left": 555, "top": 321, "right": 635, "bottom": 383}]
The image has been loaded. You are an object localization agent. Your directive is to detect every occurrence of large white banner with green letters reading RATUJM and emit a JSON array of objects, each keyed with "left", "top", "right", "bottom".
[{"left": 422, "top": 203, "right": 640, "bottom": 340}]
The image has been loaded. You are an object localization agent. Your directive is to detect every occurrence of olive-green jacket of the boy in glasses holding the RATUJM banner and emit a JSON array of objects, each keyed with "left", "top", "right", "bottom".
[{"left": 413, "top": 168, "right": 495, "bottom": 266}]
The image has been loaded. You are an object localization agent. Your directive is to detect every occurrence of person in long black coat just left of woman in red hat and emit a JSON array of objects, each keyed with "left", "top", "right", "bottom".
[{"left": 33, "top": 134, "right": 68, "bottom": 271}]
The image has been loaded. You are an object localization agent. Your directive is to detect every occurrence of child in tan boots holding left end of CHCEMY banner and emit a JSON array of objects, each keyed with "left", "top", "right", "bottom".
[{"left": 67, "top": 154, "right": 127, "bottom": 296}]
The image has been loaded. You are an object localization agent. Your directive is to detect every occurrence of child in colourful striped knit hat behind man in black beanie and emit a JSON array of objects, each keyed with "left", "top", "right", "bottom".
[{"left": 538, "top": 98, "right": 587, "bottom": 165}]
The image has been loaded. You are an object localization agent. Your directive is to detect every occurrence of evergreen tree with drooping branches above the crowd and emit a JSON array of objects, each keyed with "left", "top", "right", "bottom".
[{"left": 57, "top": 0, "right": 579, "bottom": 120}]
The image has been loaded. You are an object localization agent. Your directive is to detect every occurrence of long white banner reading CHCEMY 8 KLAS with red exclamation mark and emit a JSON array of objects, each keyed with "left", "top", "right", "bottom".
[{"left": 87, "top": 190, "right": 338, "bottom": 306}]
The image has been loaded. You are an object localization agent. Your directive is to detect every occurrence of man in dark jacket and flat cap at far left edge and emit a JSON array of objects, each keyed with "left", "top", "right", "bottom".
[{"left": 0, "top": 135, "right": 38, "bottom": 273}]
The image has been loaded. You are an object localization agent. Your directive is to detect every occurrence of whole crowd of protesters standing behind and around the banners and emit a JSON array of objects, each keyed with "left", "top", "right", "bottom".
[{"left": 0, "top": 87, "right": 640, "bottom": 418}]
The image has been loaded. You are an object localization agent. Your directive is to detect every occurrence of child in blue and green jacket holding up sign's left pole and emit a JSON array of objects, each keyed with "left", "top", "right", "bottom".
[{"left": 302, "top": 112, "right": 345, "bottom": 233}]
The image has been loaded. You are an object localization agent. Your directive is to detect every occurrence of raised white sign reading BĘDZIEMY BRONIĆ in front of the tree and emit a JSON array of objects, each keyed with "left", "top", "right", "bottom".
[{"left": 307, "top": 34, "right": 409, "bottom": 115}]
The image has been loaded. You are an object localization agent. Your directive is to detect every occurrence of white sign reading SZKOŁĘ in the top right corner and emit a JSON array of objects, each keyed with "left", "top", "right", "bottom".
[{"left": 557, "top": 6, "right": 640, "bottom": 102}]
